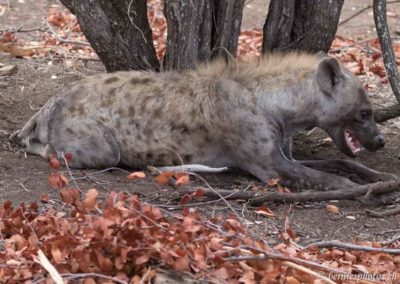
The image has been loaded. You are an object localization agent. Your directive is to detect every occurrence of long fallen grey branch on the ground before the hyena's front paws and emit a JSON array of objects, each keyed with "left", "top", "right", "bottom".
[{"left": 179, "top": 180, "right": 400, "bottom": 206}]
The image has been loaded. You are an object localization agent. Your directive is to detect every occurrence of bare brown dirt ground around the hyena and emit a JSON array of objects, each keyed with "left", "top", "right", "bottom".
[{"left": 0, "top": 0, "right": 400, "bottom": 243}]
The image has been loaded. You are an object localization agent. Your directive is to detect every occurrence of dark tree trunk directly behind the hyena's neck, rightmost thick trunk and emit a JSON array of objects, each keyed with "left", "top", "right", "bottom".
[{"left": 262, "top": 0, "right": 344, "bottom": 53}]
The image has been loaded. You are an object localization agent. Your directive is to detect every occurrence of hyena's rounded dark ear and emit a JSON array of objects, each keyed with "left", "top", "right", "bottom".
[{"left": 316, "top": 57, "right": 345, "bottom": 94}]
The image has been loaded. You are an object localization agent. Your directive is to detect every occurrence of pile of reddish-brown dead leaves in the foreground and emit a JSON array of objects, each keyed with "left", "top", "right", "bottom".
[{"left": 0, "top": 157, "right": 400, "bottom": 283}]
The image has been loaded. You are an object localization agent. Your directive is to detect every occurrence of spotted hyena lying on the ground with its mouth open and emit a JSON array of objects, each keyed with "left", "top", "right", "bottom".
[{"left": 18, "top": 53, "right": 395, "bottom": 189}]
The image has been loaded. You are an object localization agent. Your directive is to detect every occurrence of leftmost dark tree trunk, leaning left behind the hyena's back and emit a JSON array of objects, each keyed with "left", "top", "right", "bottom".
[{"left": 61, "top": 0, "right": 160, "bottom": 72}]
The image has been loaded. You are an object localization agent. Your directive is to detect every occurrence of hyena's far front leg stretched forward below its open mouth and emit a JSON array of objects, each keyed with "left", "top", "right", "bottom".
[{"left": 298, "top": 160, "right": 399, "bottom": 184}]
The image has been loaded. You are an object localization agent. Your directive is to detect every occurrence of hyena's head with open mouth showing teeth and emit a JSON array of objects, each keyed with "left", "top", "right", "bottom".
[{"left": 316, "top": 57, "right": 385, "bottom": 157}]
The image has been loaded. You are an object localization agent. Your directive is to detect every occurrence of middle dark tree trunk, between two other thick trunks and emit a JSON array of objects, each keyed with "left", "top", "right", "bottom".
[{"left": 163, "top": 0, "right": 244, "bottom": 70}]
